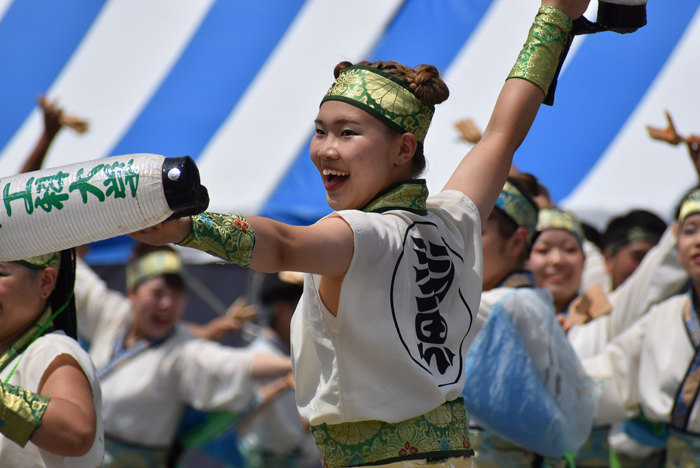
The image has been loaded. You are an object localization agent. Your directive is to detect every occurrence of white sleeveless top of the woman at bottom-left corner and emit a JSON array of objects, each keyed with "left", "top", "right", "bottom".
[{"left": 0, "top": 331, "right": 104, "bottom": 468}]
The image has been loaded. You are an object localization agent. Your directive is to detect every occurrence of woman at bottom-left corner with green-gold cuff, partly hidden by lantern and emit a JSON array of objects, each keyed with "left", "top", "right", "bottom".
[{"left": 0, "top": 251, "right": 104, "bottom": 468}]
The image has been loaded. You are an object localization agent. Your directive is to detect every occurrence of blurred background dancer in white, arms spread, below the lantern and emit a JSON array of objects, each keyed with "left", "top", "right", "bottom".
[{"left": 76, "top": 249, "right": 291, "bottom": 468}]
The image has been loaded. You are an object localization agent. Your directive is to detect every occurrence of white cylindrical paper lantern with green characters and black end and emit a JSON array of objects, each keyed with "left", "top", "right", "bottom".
[{"left": 0, "top": 154, "right": 208, "bottom": 261}]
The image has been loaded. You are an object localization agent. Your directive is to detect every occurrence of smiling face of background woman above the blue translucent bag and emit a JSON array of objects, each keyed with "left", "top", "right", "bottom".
[{"left": 528, "top": 229, "right": 585, "bottom": 311}]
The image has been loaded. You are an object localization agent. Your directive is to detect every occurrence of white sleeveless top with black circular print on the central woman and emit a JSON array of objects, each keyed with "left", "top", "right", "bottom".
[{"left": 292, "top": 191, "right": 482, "bottom": 425}]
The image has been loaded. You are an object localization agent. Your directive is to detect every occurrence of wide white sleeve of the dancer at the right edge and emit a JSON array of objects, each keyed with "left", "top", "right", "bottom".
[{"left": 582, "top": 315, "right": 652, "bottom": 424}]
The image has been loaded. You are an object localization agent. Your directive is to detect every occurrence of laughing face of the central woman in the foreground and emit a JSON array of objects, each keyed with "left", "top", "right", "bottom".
[{"left": 310, "top": 101, "right": 415, "bottom": 210}]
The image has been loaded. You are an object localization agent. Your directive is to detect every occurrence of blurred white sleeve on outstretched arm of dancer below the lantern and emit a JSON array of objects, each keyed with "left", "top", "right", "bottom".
[{"left": 178, "top": 339, "right": 256, "bottom": 411}]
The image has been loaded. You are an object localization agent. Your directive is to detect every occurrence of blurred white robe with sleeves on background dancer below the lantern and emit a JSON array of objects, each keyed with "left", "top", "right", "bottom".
[{"left": 76, "top": 262, "right": 254, "bottom": 448}]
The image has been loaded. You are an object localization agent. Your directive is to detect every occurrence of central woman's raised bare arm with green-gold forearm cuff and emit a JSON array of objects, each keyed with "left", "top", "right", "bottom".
[{"left": 445, "top": 0, "right": 588, "bottom": 219}]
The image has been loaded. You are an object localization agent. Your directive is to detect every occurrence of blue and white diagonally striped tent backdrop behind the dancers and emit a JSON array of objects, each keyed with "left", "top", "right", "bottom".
[{"left": 0, "top": 0, "right": 700, "bottom": 262}]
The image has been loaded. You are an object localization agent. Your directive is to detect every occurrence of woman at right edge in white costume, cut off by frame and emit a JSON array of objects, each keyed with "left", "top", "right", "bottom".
[{"left": 583, "top": 189, "right": 700, "bottom": 467}]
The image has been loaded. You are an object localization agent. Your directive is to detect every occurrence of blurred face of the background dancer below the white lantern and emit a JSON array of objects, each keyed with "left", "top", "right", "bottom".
[{"left": 129, "top": 276, "right": 185, "bottom": 340}]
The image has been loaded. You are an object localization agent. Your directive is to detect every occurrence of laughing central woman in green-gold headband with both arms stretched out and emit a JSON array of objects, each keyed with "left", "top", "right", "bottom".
[{"left": 130, "top": 0, "right": 588, "bottom": 468}]
